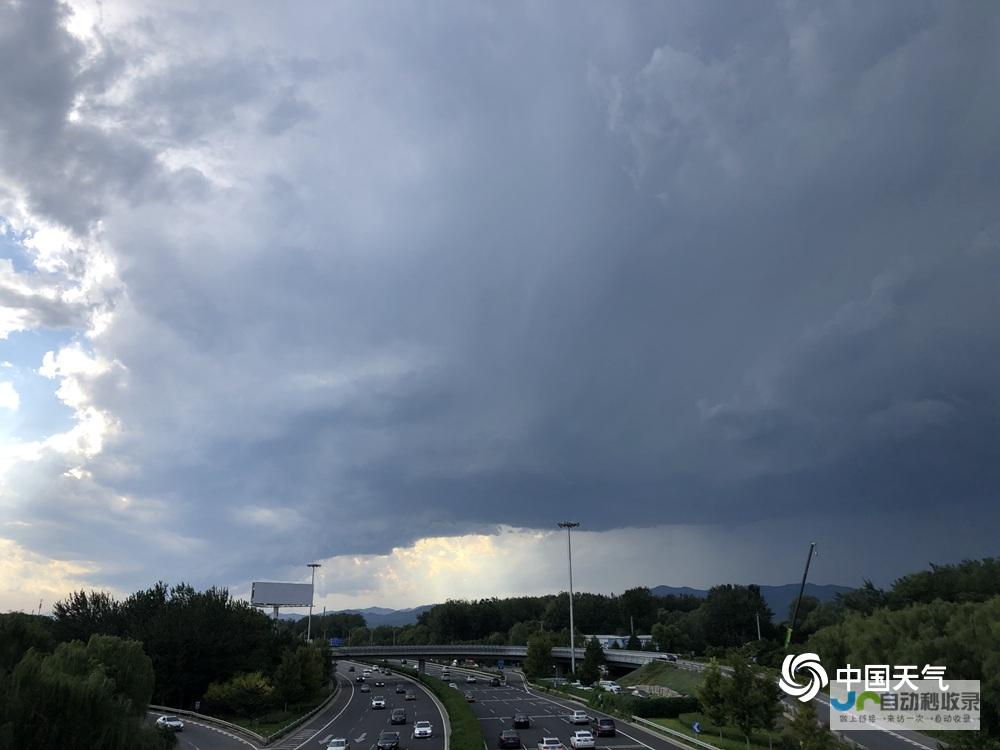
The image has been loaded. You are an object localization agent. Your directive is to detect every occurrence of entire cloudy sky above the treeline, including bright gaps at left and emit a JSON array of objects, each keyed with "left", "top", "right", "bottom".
[{"left": 0, "top": 0, "right": 1000, "bottom": 610}]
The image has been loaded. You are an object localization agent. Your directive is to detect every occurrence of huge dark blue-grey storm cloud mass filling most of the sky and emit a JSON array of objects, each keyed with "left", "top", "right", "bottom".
[{"left": 1, "top": 3, "right": 1000, "bottom": 592}]
